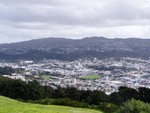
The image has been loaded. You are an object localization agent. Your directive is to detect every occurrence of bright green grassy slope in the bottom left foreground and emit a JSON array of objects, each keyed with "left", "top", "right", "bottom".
[{"left": 0, "top": 96, "right": 102, "bottom": 113}]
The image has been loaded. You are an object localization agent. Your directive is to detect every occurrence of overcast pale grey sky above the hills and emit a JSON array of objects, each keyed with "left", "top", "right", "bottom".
[{"left": 0, "top": 0, "right": 150, "bottom": 43}]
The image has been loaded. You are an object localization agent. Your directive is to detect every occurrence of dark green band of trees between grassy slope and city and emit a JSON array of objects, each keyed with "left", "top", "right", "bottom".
[{"left": 0, "top": 77, "right": 150, "bottom": 113}]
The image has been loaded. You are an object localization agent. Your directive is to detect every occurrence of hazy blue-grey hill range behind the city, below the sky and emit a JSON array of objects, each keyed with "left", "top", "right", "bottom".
[{"left": 0, "top": 37, "right": 150, "bottom": 60}]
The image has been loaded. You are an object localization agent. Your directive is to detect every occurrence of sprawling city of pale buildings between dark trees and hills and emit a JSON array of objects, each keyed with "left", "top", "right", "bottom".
[{"left": 0, "top": 58, "right": 150, "bottom": 94}]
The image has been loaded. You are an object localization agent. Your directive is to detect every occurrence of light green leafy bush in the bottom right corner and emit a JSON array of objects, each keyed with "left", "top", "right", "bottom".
[{"left": 118, "top": 99, "right": 150, "bottom": 113}]
